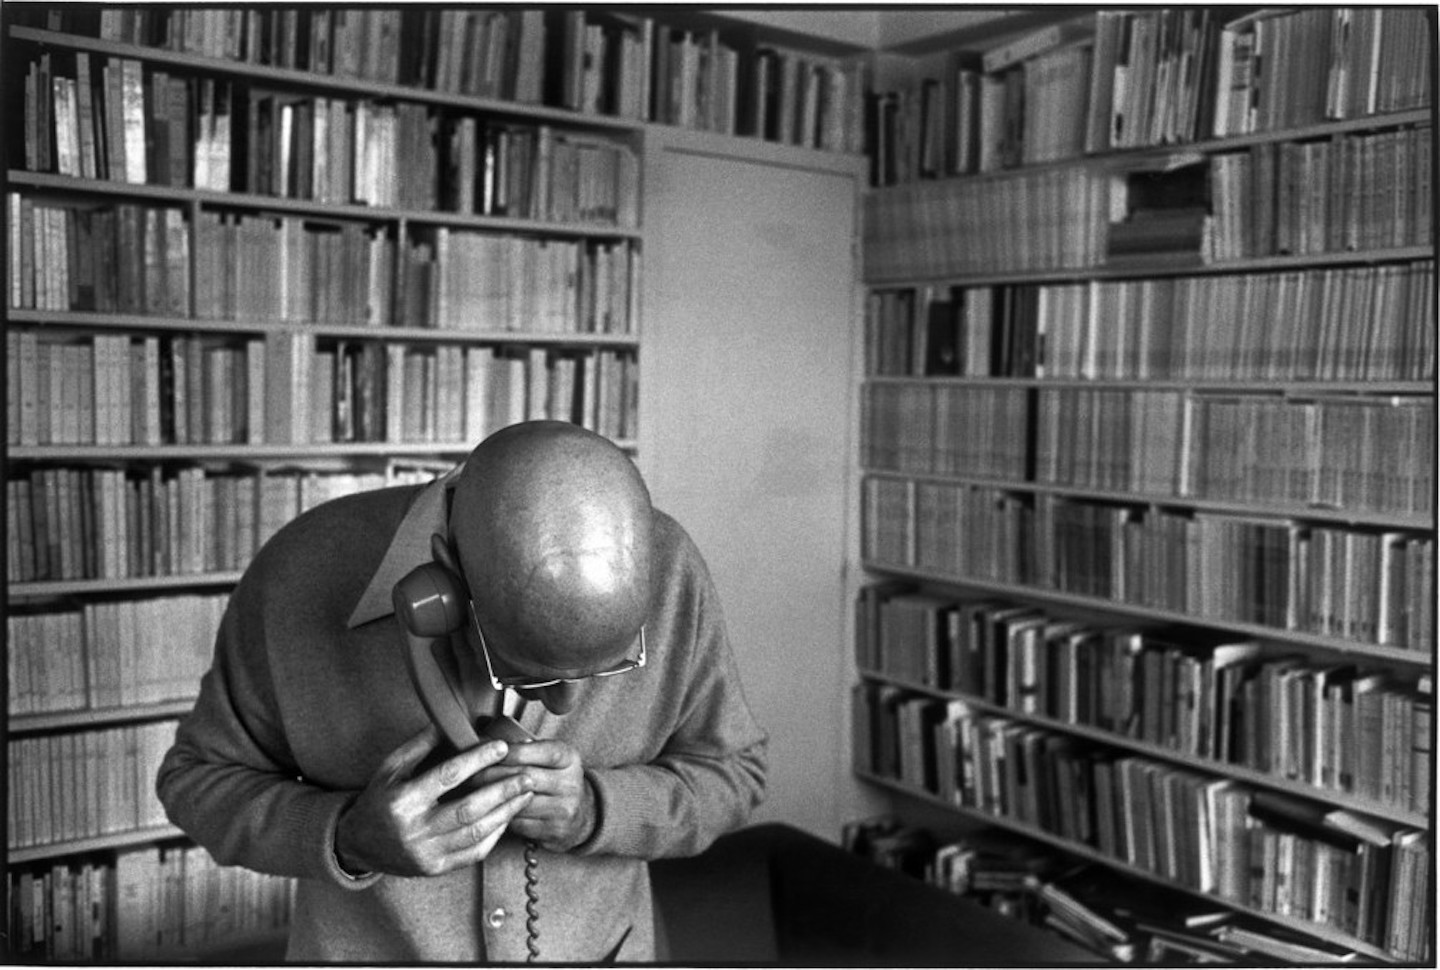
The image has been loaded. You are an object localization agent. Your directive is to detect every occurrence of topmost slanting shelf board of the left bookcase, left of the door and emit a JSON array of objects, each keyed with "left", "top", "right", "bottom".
[{"left": 10, "top": 26, "right": 644, "bottom": 134}]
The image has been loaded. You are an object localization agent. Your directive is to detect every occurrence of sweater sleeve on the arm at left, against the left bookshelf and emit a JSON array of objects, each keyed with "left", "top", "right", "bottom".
[{"left": 156, "top": 581, "right": 379, "bottom": 888}]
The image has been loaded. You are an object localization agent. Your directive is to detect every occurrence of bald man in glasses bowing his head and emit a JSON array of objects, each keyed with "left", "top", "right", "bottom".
[{"left": 157, "top": 422, "right": 766, "bottom": 963}]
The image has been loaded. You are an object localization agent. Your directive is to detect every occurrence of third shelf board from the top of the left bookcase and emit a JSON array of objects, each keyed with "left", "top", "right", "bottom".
[{"left": 9, "top": 309, "right": 639, "bottom": 348}]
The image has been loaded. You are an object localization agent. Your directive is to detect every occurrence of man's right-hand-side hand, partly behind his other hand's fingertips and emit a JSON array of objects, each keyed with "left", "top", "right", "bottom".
[{"left": 481, "top": 741, "right": 595, "bottom": 852}]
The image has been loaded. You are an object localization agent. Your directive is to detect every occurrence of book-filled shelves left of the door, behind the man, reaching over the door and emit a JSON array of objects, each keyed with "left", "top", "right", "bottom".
[{"left": 0, "top": 4, "right": 861, "bottom": 960}]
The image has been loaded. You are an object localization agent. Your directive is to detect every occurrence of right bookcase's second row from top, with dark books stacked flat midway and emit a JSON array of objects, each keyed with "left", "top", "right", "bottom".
[{"left": 864, "top": 128, "right": 1431, "bottom": 284}]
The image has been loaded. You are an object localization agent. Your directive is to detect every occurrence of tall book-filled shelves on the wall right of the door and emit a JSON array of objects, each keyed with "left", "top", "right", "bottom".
[{"left": 852, "top": 9, "right": 1436, "bottom": 961}]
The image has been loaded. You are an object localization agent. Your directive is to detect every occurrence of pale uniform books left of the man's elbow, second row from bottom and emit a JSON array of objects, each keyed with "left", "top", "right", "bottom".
[{"left": 6, "top": 721, "right": 177, "bottom": 849}]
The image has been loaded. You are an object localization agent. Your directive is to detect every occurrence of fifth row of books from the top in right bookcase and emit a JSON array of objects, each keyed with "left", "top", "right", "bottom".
[{"left": 861, "top": 476, "right": 1434, "bottom": 651}]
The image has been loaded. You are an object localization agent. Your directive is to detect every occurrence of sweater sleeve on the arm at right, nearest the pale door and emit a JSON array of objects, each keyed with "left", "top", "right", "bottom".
[{"left": 576, "top": 520, "right": 768, "bottom": 859}]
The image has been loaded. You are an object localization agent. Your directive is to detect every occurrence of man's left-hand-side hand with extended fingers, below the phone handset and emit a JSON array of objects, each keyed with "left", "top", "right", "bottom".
[{"left": 336, "top": 725, "right": 534, "bottom": 876}]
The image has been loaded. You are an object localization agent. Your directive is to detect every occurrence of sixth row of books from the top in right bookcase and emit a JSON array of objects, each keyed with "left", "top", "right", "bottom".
[{"left": 855, "top": 583, "right": 1434, "bottom": 815}]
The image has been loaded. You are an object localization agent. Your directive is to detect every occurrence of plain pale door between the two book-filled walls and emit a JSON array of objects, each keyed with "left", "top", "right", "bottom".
[{"left": 639, "top": 130, "right": 863, "bottom": 839}]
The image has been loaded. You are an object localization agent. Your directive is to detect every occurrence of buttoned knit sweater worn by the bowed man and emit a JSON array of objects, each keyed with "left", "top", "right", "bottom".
[{"left": 157, "top": 469, "right": 766, "bottom": 963}]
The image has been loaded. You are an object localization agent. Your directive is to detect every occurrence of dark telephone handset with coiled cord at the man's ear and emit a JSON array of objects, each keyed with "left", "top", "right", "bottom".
[{"left": 390, "top": 535, "right": 540, "bottom": 963}]
